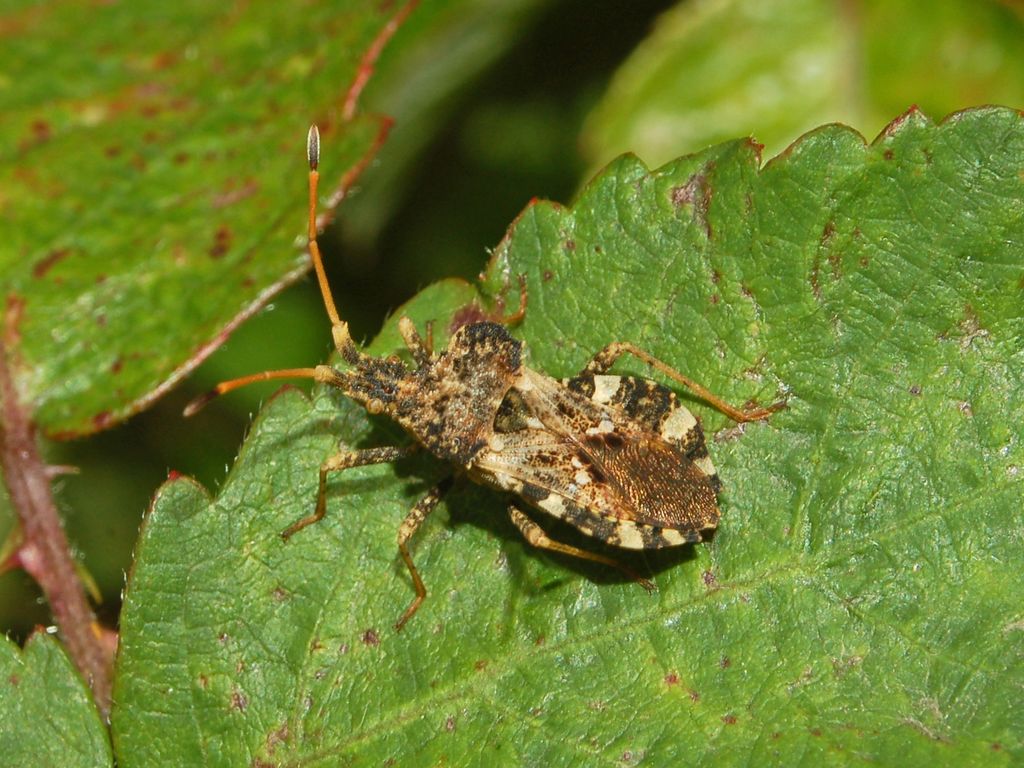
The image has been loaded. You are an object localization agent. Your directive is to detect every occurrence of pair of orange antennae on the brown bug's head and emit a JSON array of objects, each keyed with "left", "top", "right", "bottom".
[{"left": 184, "top": 125, "right": 364, "bottom": 416}]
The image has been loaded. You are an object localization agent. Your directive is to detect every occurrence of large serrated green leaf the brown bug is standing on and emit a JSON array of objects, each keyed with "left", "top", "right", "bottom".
[{"left": 113, "top": 109, "right": 1024, "bottom": 766}]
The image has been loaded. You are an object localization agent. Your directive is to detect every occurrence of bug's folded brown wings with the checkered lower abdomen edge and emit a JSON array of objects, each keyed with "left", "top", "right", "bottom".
[{"left": 474, "top": 371, "right": 719, "bottom": 549}]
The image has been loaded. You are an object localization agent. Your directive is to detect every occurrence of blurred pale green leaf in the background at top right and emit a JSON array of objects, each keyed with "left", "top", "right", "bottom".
[{"left": 584, "top": 0, "right": 1024, "bottom": 166}]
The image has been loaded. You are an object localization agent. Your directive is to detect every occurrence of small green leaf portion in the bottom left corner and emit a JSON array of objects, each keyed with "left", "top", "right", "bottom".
[{"left": 0, "top": 633, "right": 114, "bottom": 767}]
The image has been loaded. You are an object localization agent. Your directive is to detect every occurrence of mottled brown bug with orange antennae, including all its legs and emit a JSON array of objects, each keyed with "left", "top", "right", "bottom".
[{"left": 185, "top": 126, "right": 784, "bottom": 630}]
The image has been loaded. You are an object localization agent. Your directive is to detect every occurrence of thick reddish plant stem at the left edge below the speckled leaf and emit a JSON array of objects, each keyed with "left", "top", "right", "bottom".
[{"left": 0, "top": 302, "right": 113, "bottom": 718}]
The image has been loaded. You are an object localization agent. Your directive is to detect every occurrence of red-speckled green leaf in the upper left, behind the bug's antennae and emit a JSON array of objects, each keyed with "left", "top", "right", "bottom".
[{"left": 0, "top": 0, "right": 402, "bottom": 436}]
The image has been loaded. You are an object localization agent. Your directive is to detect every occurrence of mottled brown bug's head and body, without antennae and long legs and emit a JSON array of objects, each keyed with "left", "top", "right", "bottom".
[{"left": 319, "top": 319, "right": 720, "bottom": 549}]
